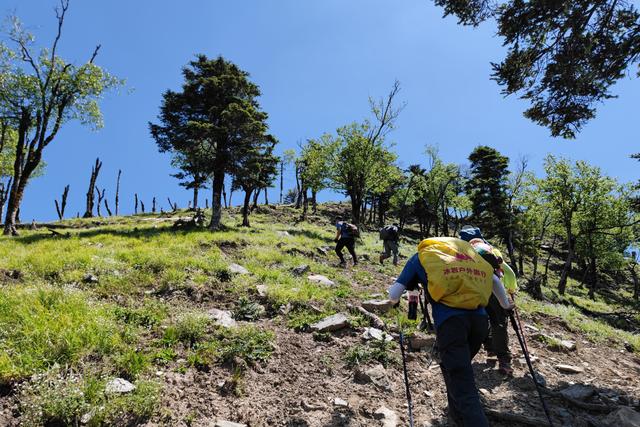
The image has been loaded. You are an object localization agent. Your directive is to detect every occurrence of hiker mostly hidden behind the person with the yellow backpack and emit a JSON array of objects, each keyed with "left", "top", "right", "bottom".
[{"left": 460, "top": 226, "right": 518, "bottom": 376}]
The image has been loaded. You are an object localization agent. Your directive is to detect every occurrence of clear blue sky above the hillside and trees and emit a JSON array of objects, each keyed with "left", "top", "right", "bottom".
[{"left": 5, "top": 0, "right": 640, "bottom": 221}]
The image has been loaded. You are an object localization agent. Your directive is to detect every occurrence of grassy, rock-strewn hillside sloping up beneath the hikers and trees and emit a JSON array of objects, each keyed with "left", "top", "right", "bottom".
[{"left": 0, "top": 205, "right": 640, "bottom": 426}]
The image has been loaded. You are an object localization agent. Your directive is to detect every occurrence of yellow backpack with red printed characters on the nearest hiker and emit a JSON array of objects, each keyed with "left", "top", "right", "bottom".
[{"left": 418, "top": 237, "right": 493, "bottom": 310}]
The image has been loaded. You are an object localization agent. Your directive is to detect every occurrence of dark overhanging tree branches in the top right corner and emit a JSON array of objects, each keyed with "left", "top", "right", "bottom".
[{"left": 435, "top": 0, "right": 640, "bottom": 138}]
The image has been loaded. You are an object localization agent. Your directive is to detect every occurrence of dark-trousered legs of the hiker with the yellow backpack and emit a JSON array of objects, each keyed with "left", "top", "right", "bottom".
[{"left": 436, "top": 315, "right": 489, "bottom": 427}]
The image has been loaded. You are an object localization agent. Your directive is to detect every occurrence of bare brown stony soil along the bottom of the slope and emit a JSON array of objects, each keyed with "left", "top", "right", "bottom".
[{"left": 149, "top": 310, "right": 640, "bottom": 427}]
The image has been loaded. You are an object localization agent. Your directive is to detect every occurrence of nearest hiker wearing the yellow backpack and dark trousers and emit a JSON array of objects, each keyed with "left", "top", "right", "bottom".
[{"left": 389, "top": 237, "right": 514, "bottom": 427}]
